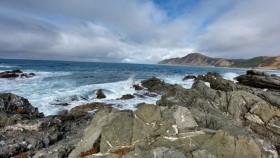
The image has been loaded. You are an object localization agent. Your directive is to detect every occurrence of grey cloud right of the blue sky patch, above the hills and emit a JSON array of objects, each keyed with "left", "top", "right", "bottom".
[{"left": 197, "top": 0, "right": 280, "bottom": 58}]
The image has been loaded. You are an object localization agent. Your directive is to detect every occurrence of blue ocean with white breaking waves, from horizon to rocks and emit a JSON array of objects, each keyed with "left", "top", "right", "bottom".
[{"left": 0, "top": 59, "right": 280, "bottom": 115}]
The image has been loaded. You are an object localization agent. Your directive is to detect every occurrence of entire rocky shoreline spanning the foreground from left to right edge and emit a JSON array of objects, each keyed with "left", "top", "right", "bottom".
[{"left": 0, "top": 70, "right": 280, "bottom": 158}]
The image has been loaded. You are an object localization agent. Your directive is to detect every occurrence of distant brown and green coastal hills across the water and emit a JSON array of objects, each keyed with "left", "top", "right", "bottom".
[{"left": 158, "top": 53, "right": 280, "bottom": 69}]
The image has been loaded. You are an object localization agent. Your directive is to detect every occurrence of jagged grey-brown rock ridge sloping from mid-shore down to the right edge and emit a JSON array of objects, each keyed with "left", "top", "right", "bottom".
[{"left": 140, "top": 73, "right": 280, "bottom": 157}]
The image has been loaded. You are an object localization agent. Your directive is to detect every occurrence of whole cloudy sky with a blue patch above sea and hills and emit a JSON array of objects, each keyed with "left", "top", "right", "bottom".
[{"left": 0, "top": 0, "right": 280, "bottom": 63}]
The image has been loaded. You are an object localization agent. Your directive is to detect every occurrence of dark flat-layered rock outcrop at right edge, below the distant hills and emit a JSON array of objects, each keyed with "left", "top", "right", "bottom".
[{"left": 236, "top": 70, "right": 280, "bottom": 90}]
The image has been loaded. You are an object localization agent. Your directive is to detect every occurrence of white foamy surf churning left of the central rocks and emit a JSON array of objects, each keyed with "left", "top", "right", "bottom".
[{"left": 0, "top": 72, "right": 160, "bottom": 115}]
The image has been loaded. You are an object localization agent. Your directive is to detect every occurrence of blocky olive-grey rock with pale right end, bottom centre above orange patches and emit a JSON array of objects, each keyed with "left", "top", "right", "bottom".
[{"left": 70, "top": 104, "right": 197, "bottom": 157}]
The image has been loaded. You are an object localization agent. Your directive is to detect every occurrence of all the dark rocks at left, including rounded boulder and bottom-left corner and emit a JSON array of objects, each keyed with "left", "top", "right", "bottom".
[{"left": 0, "top": 93, "right": 108, "bottom": 158}]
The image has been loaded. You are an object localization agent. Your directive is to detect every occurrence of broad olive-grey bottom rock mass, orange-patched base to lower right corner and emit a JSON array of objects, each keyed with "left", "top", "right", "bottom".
[{"left": 69, "top": 104, "right": 264, "bottom": 158}]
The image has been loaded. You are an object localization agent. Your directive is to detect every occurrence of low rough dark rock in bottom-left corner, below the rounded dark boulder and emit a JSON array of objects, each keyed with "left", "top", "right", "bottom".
[{"left": 0, "top": 112, "right": 89, "bottom": 158}]
